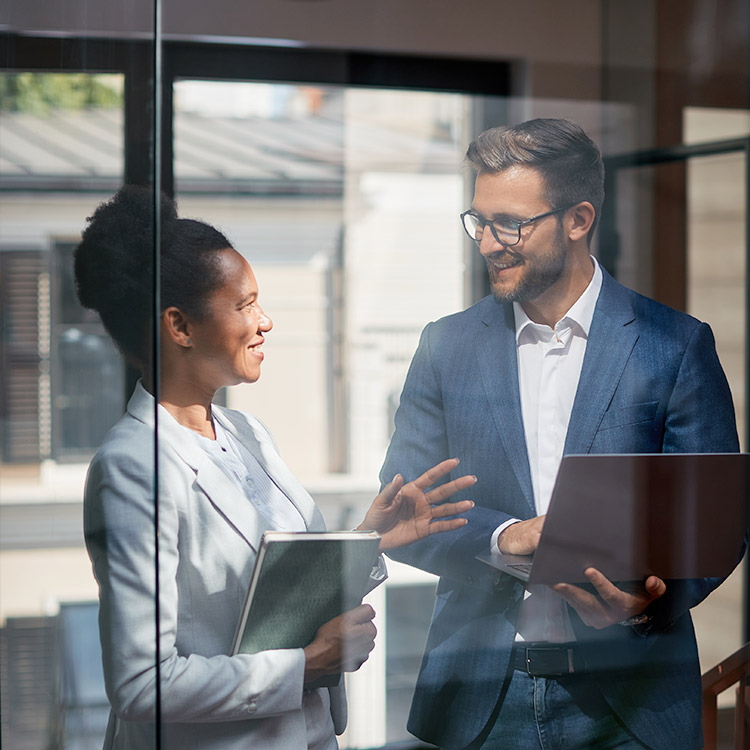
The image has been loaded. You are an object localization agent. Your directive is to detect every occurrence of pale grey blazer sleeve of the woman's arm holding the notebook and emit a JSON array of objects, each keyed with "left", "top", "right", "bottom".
[{"left": 84, "top": 439, "right": 304, "bottom": 722}]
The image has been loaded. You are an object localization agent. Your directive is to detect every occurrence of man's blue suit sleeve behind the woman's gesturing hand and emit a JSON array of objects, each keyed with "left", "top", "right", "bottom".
[{"left": 380, "top": 323, "right": 511, "bottom": 586}]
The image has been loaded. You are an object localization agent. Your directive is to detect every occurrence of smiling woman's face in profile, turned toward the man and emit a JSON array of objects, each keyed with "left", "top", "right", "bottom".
[{"left": 190, "top": 248, "right": 273, "bottom": 390}]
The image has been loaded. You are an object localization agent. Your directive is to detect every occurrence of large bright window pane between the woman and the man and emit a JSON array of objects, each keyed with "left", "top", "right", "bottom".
[{"left": 175, "top": 80, "right": 490, "bottom": 748}]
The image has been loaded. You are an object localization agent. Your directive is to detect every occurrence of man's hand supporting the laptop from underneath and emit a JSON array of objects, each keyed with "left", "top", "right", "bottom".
[{"left": 552, "top": 568, "right": 667, "bottom": 630}]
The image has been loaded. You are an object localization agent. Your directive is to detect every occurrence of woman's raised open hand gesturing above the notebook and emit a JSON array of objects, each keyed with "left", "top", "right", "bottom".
[{"left": 357, "top": 458, "right": 477, "bottom": 550}]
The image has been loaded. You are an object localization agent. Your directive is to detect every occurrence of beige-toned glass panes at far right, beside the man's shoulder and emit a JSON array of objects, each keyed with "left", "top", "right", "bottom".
[{"left": 684, "top": 108, "right": 750, "bottom": 706}]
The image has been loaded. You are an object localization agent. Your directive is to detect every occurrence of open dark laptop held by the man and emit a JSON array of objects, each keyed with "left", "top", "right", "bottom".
[{"left": 477, "top": 453, "right": 750, "bottom": 584}]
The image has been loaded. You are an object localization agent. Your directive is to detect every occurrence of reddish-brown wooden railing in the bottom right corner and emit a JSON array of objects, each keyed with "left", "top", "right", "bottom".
[{"left": 703, "top": 643, "right": 750, "bottom": 750}]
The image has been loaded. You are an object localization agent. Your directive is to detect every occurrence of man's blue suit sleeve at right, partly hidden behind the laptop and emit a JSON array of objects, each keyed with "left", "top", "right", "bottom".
[{"left": 637, "top": 323, "right": 744, "bottom": 634}]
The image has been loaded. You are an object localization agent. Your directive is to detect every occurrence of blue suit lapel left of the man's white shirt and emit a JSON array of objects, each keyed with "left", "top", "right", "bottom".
[{"left": 476, "top": 299, "right": 536, "bottom": 515}]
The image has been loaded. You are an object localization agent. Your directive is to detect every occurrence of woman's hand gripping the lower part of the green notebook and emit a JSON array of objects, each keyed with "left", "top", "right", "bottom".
[{"left": 304, "top": 604, "right": 377, "bottom": 684}]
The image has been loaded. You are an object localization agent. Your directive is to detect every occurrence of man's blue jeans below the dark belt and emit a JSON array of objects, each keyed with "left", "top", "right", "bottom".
[{"left": 481, "top": 671, "right": 646, "bottom": 750}]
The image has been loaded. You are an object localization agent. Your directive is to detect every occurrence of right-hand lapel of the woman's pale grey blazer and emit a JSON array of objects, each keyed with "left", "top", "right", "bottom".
[{"left": 214, "top": 407, "right": 325, "bottom": 531}]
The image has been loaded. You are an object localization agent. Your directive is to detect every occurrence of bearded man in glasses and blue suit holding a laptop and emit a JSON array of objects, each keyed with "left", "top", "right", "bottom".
[{"left": 382, "top": 120, "right": 738, "bottom": 750}]
